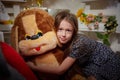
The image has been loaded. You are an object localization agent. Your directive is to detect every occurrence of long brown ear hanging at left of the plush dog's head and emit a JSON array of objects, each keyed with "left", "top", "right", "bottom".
[{"left": 11, "top": 26, "right": 19, "bottom": 52}]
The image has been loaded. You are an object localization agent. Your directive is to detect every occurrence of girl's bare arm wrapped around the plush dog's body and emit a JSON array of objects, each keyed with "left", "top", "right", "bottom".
[{"left": 27, "top": 57, "right": 76, "bottom": 75}]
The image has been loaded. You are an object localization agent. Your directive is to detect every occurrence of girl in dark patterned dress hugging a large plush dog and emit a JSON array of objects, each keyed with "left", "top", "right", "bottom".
[{"left": 27, "top": 11, "right": 120, "bottom": 80}]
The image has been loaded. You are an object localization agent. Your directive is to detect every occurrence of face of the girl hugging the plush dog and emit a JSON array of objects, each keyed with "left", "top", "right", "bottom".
[{"left": 57, "top": 20, "right": 73, "bottom": 44}]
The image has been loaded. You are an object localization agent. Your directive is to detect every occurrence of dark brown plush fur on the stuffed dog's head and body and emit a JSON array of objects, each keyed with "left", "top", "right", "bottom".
[{"left": 11, "top": 9, "right": 63, "bottom": 69}]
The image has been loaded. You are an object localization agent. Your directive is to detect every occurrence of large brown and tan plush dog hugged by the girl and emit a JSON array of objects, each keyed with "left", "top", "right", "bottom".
[{"left": 11, "top": 9, "right": 64, "bottom": 79}]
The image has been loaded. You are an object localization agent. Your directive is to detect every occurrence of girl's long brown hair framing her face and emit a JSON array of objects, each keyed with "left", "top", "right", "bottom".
[{"left": 54, "top": 10, "right": 78, "bottom": 56}]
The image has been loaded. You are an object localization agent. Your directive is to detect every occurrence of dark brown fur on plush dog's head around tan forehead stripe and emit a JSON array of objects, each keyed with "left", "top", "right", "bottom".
[{"left": 11, "top": 9, "right": 54, "bottom": 46}]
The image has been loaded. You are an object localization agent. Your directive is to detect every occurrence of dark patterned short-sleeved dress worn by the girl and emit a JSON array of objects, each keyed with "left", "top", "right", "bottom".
[{"left": 69, "top": 34, "right": 120, "bottom": 80}]
